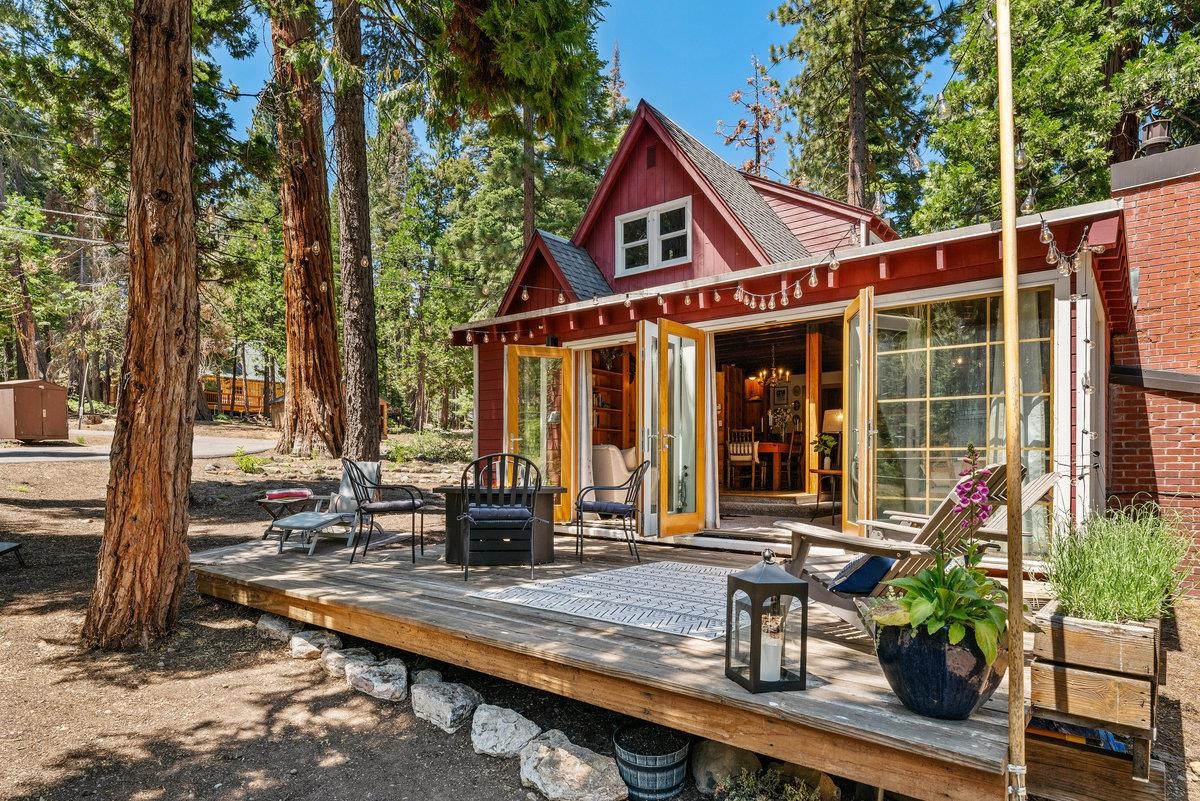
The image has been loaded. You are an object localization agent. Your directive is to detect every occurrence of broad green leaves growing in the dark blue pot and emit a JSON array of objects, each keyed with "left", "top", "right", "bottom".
[{"left": 871, "top": 543, "right": 1008, "bottom": 664}]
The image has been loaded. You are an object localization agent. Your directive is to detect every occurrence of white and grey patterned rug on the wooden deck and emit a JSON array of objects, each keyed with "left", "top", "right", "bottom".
[{"left": 472, "top": 561, "right": 736, "bottom": 640}]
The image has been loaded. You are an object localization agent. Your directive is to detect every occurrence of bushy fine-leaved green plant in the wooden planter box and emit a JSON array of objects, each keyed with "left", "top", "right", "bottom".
[{"left": 1046, "top": 504, "right": 1190, "bottom": 622}]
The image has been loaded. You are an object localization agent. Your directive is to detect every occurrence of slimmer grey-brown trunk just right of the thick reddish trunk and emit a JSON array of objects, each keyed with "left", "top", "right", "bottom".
[{"left": 334, "top": 0, "right": 382, "bottom": 462}]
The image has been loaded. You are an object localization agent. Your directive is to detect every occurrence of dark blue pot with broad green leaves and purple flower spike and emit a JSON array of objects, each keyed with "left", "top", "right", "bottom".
[{"left": 871, "top": 447, "right": 1008, "bottom": 721}]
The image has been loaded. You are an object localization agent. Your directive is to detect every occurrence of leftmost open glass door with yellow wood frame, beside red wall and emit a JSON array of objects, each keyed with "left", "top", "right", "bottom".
[{"left": 504, "top": 345, "right": 575, "bottom": 523}]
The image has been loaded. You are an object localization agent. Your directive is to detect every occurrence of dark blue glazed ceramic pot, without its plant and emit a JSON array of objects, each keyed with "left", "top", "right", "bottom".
[{"left": 876, "top": 626, "right": 1008, "bottom": 721}]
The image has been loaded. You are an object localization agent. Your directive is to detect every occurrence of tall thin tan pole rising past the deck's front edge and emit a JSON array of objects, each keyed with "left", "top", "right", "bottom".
[{"left": 996, "top": 0, "right": 1025, "bottom": 801}]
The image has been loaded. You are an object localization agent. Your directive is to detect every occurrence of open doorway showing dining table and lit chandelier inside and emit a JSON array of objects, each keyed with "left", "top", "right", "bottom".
[{"left": 714, "top": 317, "right": 844, "bottom": 536}]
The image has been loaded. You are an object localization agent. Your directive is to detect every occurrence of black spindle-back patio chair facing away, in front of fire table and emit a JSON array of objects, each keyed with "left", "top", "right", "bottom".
[{"left": 458, "top": 453, "right": 546, "bottom": 582}]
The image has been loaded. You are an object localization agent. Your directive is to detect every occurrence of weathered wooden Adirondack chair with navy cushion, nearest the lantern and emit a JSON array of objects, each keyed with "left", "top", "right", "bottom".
[{"left": 775, "top": 464, "right": 1024, "bottom": 632}]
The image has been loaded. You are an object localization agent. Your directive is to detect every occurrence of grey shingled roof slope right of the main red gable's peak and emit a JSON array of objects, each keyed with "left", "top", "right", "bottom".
[{"left": 646, "top": 103, "right": 810, "bottom": 261}]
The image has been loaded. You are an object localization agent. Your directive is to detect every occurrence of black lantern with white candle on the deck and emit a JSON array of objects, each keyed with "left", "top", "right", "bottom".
[{"left": 725, "top": 549, "right": 809, "bottom": 693}]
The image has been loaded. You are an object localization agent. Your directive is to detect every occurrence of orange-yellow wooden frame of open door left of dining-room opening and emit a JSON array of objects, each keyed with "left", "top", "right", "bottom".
[{"left": 655, "top": 318, "right": 708, "bottom": 537}]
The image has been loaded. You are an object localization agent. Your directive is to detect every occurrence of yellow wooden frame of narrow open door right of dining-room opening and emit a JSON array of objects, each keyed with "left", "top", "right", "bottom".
[{"left": 840, "top": 287, "right": 875, "bottom": 534}]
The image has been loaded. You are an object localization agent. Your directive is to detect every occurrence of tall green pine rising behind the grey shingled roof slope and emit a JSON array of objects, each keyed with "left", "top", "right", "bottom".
[{"left": 772, "top": 0, "right": 958, "bottom": 230}]
